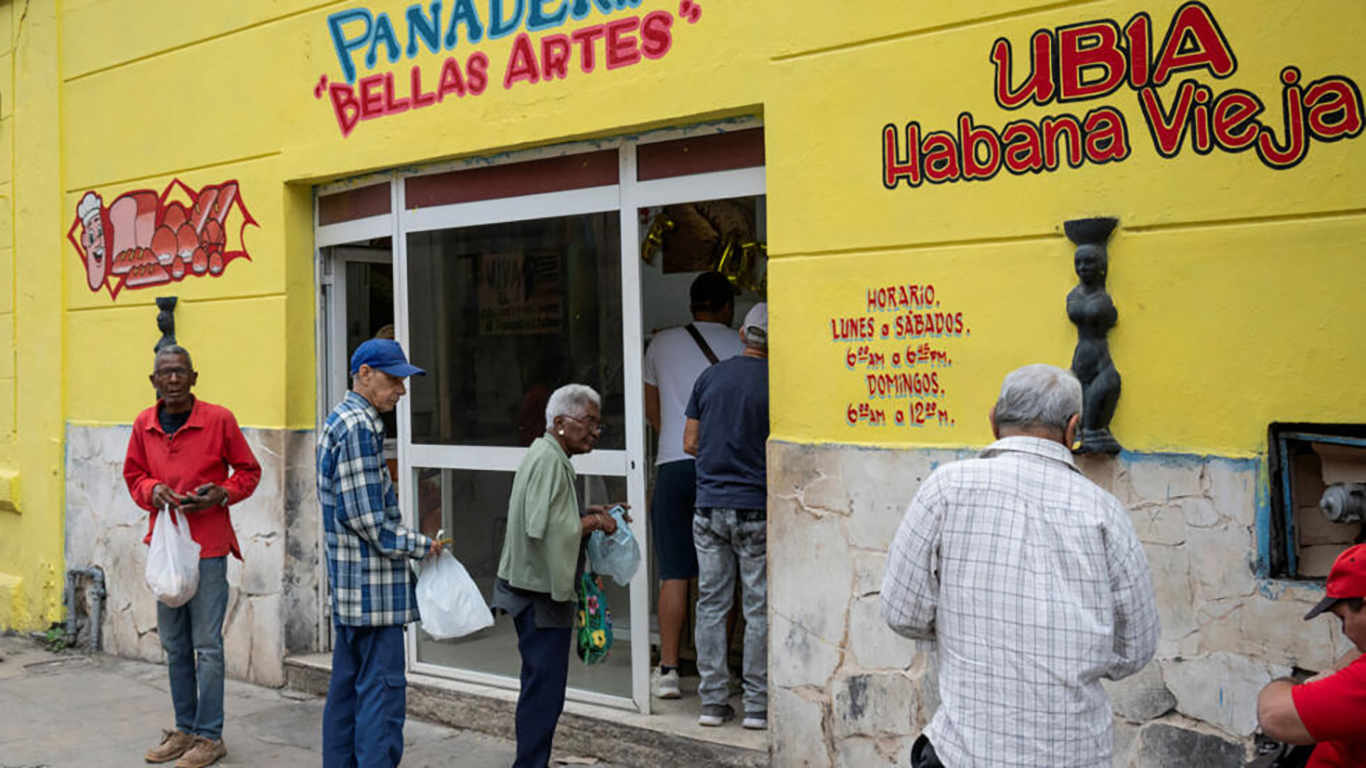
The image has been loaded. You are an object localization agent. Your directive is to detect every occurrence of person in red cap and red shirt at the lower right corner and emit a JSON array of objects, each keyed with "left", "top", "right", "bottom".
[{"left": 1257, "top": 544, "right": 1366, "bottom": 768}]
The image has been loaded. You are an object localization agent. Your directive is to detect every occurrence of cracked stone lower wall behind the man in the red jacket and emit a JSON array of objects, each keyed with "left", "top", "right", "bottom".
[{"left": 66, "top": 425, "right": 320, "bottom": 686}]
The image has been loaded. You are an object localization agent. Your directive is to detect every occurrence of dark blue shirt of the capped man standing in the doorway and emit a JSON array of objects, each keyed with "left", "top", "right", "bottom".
[{"left": 684, "top": 357, "right": 768, "bottom": 510}]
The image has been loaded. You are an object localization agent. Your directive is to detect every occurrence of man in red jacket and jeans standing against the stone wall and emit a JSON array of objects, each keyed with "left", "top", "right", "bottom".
[{"left": 123, "top": 344, "right": 261, "bottom": 768}]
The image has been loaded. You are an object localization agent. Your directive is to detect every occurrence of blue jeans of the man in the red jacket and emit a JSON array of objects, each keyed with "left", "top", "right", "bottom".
[{"left": 157, "top": 556, "right": 228, "bottom": 741}]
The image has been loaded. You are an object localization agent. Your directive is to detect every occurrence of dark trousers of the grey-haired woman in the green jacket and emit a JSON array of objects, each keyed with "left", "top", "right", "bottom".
[{"left": 512, "top": 605, "right": 574, "bottom": 768}]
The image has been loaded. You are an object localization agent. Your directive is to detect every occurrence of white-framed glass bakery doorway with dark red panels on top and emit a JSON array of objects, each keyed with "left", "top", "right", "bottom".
[{"left": 316, "top": 123, "right": 764, "bottom": 712}]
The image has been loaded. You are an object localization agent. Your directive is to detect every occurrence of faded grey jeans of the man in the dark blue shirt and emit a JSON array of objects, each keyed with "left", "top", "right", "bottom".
[{"left": 693, "top": 508, "right": 768, "bottom": 712}]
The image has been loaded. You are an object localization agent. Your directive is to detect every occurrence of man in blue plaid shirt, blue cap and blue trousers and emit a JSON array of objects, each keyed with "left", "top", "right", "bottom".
[{"left": 318, "top": 339, "right": 440, "bottom": 768}]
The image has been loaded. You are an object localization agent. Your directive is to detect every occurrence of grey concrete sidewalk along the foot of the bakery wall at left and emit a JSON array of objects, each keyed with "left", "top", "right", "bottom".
[{"left": 0, "top": 637, "right": 613, "bottom": 768}]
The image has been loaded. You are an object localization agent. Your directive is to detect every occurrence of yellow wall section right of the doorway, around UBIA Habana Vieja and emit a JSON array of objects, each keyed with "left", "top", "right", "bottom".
[{"left": 765, "top": 1, "right": 1366, "bottom": 455}]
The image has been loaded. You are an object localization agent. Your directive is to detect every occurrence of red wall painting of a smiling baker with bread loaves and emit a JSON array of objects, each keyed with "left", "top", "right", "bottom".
[{"left": 67, "top": 179, "right": 257, "bottom": 298}]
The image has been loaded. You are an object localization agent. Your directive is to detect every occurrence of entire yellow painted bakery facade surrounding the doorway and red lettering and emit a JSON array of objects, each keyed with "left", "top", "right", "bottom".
[{"left": 0, "top": 0, "right": 1366, "bottom": 626}]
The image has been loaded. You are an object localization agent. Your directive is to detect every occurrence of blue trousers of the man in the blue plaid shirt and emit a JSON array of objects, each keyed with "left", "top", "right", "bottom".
[{"left": 322, "top": 625, "right": 407, "bottom": 768}]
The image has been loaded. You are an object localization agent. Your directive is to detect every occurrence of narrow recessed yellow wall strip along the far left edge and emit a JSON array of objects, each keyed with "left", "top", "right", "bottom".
[{"left": 0, "top": 3, "right": 63, "bottom": 629}]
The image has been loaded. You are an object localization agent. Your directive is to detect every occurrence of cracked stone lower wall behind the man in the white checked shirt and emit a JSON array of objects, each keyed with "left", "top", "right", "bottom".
[{"left": 768, "top": 441, "right": 1350, "bottom": 768}]
